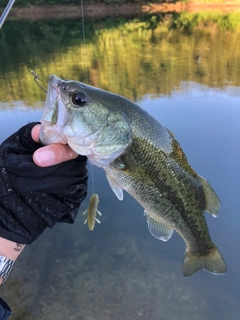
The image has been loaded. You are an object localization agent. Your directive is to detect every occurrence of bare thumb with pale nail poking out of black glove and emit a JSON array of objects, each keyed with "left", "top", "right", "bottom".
[{"left": 33, "top": 143, "right": 78, "bottom": 167}]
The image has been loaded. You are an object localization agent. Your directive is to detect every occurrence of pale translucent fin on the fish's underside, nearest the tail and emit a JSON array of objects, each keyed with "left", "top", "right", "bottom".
[{"left": 144, "top": 211, "right": 173, "bottom": 241}]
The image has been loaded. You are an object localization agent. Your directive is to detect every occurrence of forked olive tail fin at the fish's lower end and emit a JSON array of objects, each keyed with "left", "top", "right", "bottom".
[{"left": 182, "top": 244, "right": 227, "bottom": 277}]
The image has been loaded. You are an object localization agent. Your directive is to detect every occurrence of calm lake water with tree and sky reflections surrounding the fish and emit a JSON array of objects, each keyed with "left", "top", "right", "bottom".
[{"left": 0, "top": 13, "right": 240, "bottom": 320}]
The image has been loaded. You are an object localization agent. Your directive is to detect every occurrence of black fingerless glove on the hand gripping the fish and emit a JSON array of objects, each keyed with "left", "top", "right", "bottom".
[{"left": 0, "top": 123, "right": 88, "bottom": 244}]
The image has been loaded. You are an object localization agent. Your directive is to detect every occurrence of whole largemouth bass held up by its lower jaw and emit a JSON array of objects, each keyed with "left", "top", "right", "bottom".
[{"left": 40, "top": 75, "right": 227, "bottom": 277}]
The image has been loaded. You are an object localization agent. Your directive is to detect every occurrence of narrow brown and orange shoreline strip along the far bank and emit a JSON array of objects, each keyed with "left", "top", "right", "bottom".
[{"left": 0, "top": 0, "right": 240, "bottom": 20}]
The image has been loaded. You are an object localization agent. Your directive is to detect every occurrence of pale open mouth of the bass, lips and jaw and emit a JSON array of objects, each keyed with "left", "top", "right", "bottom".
[{"left": 39, "top": 75, "right": 70, "bottom": 144}]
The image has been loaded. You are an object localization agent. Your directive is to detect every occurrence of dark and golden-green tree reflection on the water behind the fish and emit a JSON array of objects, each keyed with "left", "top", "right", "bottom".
[{"left": 0, "top": 13, "right": 240, "bottom": 103}]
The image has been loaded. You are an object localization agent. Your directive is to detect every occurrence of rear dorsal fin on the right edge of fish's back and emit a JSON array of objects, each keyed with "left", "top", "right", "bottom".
[{"left": 198, "top": 175, "right": 221, "bottom": 218}]
